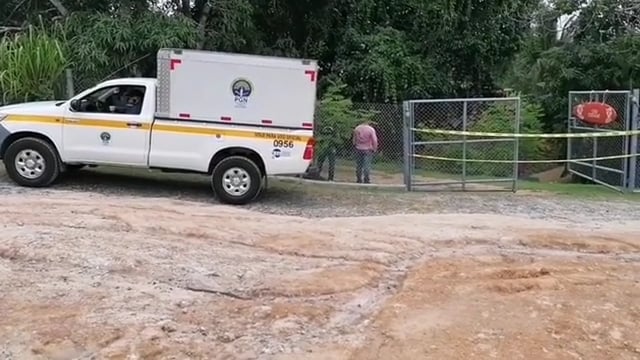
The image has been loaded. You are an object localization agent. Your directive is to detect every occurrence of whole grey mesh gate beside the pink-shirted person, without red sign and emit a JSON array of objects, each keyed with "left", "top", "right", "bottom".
[{"left": 403, "top": 97, "right": 520, "bottom": 191}]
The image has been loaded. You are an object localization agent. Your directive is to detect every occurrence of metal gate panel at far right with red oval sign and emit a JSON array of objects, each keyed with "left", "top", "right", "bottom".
[{"left": 567, "top": 90, "right": 638, "bottom": 191}]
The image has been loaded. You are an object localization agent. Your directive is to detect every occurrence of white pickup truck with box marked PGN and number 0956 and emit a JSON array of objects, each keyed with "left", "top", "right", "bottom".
[{"left": 0, "top": 49, "right": 318, "bottom": 204}]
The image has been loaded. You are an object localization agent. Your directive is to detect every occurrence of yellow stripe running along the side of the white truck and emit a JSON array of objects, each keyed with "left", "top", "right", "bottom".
[{"left": 5, "top": 115, "right": 311, "bottom": 144}]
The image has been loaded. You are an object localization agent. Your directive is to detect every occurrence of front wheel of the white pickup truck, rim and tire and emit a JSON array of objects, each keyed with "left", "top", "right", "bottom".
[{"left": 4, "top": 137, "right": 60, "bottom": 187}]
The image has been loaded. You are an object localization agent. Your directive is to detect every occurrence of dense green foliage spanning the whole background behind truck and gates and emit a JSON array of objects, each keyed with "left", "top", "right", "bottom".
[{"left": 0, "top": 0, "right": 640, "bottom": 174}]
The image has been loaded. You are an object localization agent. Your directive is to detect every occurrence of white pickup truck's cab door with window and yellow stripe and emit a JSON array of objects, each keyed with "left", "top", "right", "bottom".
[{"left": 62, "top": 85, "right": 155, "bottom": 166}]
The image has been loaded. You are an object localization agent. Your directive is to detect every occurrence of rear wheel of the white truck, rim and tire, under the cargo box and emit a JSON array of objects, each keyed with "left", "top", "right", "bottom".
[{"left": 211, "top": 156, "right": 262, "bottom": 205}]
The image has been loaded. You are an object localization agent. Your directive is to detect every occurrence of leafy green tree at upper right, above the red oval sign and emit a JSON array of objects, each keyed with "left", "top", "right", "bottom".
[{"left": 502, "top": 0, "right": 640, "bottom": 132}]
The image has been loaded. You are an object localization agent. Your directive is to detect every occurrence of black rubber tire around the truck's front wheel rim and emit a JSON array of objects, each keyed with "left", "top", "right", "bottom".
[{"left": 4, "top": 137, "right": 60, "bottom": 187}]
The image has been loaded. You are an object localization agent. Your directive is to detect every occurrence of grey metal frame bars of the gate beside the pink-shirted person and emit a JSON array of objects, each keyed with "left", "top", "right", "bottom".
[{"left": 402, "top": 96, "right": 522, "bottom": 193}]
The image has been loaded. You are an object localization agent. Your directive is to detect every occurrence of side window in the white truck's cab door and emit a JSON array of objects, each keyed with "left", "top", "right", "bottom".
[{"left": 72, "top": 85, "right": 146, "bottom": 115}]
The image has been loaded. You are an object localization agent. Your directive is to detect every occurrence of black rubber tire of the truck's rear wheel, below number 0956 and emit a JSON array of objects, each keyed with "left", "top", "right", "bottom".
[{"left": 211, "top": 156, "right": 262, "bottom": 205}]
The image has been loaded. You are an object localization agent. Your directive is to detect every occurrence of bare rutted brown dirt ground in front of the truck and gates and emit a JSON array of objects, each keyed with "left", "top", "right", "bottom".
[{"left": 0, "top": 191, "right": 640, "bottom": 360}]
